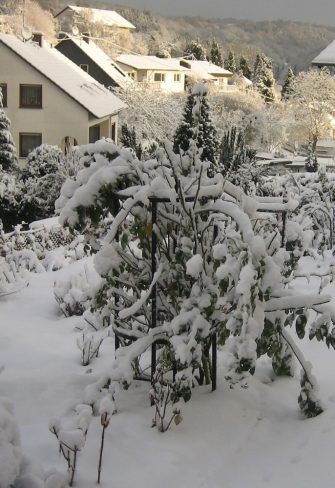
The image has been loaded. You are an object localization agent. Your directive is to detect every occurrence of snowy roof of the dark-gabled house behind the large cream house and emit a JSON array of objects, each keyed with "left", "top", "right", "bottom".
[{"left": 57, "top": 35, "right": 134, "bottom": 86}]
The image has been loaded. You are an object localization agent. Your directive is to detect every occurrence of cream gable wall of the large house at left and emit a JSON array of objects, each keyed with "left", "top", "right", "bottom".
[{"left": 0, "top": 44, "right": 89, "bottom": 158}]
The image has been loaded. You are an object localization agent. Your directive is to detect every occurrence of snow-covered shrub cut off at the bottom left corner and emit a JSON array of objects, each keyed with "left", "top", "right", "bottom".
[{"left": 0, "top": 398, "right": 22, "bottom": 488}]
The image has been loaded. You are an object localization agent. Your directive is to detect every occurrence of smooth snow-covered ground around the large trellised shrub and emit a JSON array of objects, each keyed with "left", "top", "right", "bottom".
[{"left": 0, "top": 255, "right": 335, "bottom": 488}]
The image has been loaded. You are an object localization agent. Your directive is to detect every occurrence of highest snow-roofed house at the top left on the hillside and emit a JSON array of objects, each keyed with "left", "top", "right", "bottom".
[{"left": 55, "top": 5, "right": 136, "bottom": 38}]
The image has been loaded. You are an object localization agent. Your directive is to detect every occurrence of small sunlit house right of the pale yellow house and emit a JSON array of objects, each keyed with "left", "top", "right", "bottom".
[{"left": 179, "top": 59, "right": 238, "bottom": 92}]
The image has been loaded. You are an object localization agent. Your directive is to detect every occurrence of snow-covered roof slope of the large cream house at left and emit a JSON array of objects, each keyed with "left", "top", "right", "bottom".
[{"left": 0, "top": 33, "right": 126, "bottom": 119}]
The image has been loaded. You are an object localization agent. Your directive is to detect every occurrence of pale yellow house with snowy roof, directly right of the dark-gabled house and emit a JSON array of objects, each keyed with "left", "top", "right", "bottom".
[{"left": 116, "top": 54, "right": 189, "bottom": 93}]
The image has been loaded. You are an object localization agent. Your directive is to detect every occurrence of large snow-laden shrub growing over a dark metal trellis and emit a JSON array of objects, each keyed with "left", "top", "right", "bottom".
[{"left": 58, "top": 127, "right": 335, "bottom": 415}]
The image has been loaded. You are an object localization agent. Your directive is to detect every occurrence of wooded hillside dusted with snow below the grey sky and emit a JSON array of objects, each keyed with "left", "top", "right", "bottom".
[{"left": 33, "top": 0, "right": 335, "bottom": 78}]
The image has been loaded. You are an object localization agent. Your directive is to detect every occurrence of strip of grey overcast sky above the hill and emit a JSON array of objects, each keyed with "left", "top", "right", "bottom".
[{"left": 110, "top": 0, "right": 335, "bottom": 26}]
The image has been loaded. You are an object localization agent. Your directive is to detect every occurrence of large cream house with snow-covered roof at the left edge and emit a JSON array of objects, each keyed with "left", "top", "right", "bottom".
[{"left": 0, "top": 34, "right": 126, "bottom": 158}]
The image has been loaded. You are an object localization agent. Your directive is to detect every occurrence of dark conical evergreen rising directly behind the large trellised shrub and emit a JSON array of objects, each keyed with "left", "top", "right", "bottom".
[{"left": 173, "top": 83, "right": 219, "bottom": 165}]
